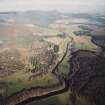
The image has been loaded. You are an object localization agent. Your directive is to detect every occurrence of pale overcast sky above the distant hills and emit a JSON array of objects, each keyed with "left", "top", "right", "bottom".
[{"left": 0, "top": 0, "right": 105, "bottom": 12}]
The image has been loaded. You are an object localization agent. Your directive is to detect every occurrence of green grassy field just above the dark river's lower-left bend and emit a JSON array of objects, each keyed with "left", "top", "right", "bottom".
[{"left": 5, "top": 72, "right": 58, "bottom": 95}]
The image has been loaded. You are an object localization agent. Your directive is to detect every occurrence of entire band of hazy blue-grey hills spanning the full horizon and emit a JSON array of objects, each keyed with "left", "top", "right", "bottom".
[{"left": 0, "top": 11, "right": 105, "bottom": 27}]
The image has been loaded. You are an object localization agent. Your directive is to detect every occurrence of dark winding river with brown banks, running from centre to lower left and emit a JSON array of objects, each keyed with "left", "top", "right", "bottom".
[{"left": 0, "top": 43, "right": 69, "bottom": 105}]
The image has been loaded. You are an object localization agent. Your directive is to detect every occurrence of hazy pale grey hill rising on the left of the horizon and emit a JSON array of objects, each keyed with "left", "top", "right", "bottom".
[{"left": 0, "top": 11, "right": 62, "bottom": 27}]
